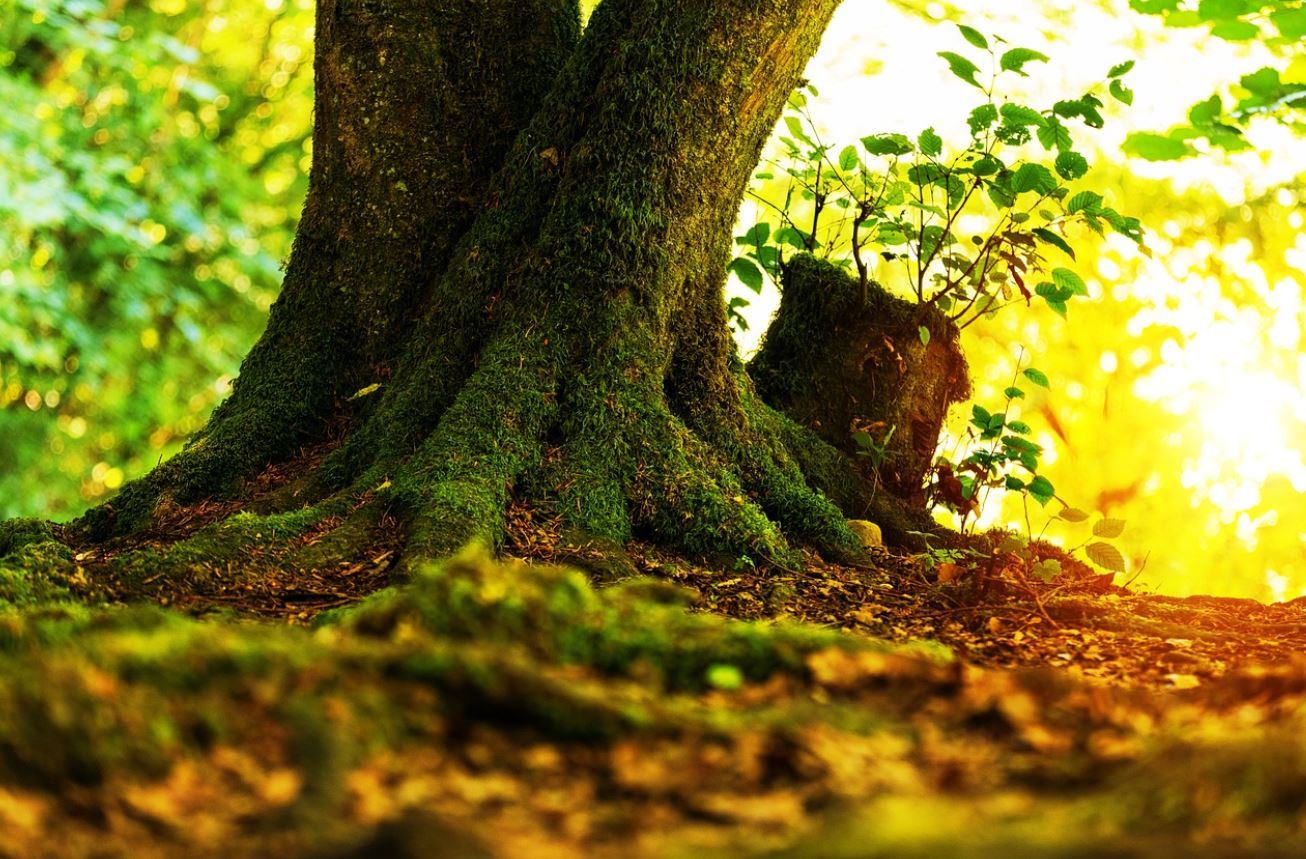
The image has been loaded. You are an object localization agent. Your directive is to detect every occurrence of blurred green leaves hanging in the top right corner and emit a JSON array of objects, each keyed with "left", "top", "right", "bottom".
[{"left": 1124, "top": 0, "right": 1306, "bottom": 161}]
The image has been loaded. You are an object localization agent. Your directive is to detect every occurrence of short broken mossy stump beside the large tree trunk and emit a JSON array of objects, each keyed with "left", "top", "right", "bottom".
[{"left": 748, "top": 256, "right": 970, "bottom": 507}]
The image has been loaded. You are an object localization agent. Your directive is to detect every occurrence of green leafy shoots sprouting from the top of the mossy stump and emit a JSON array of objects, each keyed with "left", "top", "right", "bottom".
[{"left": 730, "top": 25, "right": 1143, "bottom": 327}]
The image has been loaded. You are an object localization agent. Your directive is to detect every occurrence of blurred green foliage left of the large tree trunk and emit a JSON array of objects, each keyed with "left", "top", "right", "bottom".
[{"left": 0, "top": 0, "right": 311, "bottom": 516}]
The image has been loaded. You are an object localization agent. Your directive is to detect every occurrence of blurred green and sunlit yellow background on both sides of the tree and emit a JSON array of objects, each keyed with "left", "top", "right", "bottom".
[{"left": 0, "top": 0, "right": 1306, "bottom": 599}]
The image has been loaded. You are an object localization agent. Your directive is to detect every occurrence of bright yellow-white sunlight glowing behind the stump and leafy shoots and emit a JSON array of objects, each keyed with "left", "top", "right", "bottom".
[{"left": 739, "top": 3, "right": 1306, "bottom": 599}]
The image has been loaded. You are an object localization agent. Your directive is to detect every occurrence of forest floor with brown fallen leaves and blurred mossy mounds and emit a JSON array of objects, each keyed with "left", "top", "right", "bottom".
[{"left": 0, "top": 480, "right": 1306, "bottom": 859}]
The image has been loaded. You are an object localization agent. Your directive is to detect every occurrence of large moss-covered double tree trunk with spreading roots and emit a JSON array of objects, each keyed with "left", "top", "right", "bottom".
[{"left": 74, "top": 0, "right": 908, "bottom": 571}]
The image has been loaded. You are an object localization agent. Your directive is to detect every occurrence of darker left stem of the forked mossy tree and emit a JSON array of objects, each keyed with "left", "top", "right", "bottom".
[{"left": 90, "top": 0, "right": 580, "bottom": 533}]
